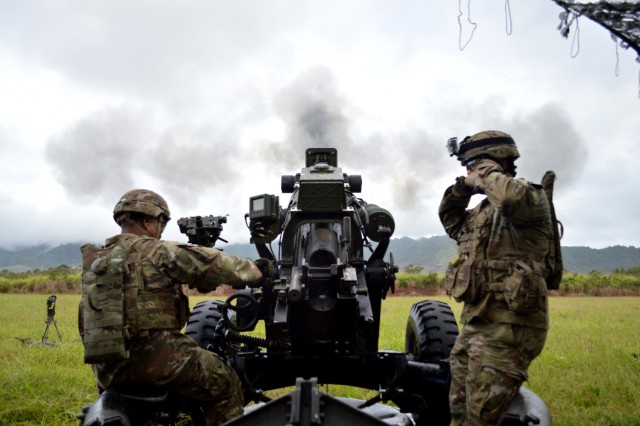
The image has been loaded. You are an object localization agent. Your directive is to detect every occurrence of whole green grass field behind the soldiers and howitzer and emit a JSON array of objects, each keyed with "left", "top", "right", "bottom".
[{"left": 0, "top": 294, "right": 640, "bottom": 426}]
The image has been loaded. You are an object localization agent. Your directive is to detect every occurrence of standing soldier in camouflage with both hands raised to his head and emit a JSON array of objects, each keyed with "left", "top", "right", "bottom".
[{"left": 439, "top": 131, "right": 552, "bottom": 425}]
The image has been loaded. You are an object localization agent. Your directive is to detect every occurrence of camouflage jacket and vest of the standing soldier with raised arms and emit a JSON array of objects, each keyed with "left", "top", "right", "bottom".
[{"left": 438, "top": 165, "right": 551, "bottom": 329}]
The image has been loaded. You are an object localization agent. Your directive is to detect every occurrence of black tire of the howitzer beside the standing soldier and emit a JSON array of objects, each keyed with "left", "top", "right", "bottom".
[{"left": 405, "top": 300, "right": 458, "bottom": 363}]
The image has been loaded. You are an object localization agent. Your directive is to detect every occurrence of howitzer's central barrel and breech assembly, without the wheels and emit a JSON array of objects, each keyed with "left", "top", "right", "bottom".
[{"left": 248, "top": 149, "right": 396, "bottom": 355}]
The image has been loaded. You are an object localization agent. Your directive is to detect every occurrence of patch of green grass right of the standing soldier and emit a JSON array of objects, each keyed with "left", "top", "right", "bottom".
[{"left": 529, "top": 297, "right": 640, "bottom": 426}]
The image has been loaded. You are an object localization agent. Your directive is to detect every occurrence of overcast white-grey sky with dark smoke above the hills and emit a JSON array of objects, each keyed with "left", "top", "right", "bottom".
[{"left": 0, "top": 0, "right": 640, "bottom": 248}]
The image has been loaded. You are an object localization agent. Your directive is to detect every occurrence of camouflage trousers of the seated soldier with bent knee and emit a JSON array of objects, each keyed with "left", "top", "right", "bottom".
[{"left": 93, "top": 330, "right": 244, "bottom": 425}]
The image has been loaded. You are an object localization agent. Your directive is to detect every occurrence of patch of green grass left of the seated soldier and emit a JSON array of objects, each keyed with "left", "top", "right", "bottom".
[{"left": 0, "top": 294, "right": 96, "bottom": 425}]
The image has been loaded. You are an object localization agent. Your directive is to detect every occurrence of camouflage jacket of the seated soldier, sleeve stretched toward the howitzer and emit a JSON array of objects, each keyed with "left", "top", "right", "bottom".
[{"left": 80, "top": 233, "right": 262, "bottom": 336}]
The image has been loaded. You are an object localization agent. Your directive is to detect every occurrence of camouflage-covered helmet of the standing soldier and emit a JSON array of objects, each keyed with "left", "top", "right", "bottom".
[{"left": 458, "top": 130, "right": 520, "bottom": 166}]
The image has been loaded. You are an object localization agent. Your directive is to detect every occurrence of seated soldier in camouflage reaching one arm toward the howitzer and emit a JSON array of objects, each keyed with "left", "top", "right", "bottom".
[{"left": 79, "top": 189, "right": 262, "bottom": 425}]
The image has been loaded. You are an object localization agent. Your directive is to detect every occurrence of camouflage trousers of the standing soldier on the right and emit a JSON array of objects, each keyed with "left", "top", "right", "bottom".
[{"left": 449, "top": 320, "right": 547, "bottom": 426}]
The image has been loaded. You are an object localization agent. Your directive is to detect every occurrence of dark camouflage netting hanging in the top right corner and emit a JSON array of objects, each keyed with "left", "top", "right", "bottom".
[{"left": 553, "top": 0, "right": 640, "bottom": 57}]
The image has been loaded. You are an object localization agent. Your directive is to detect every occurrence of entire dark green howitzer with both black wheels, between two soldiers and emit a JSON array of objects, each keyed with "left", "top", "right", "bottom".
[{"left": 186, "top": 148, "right": 457, "bottom": 424}]
